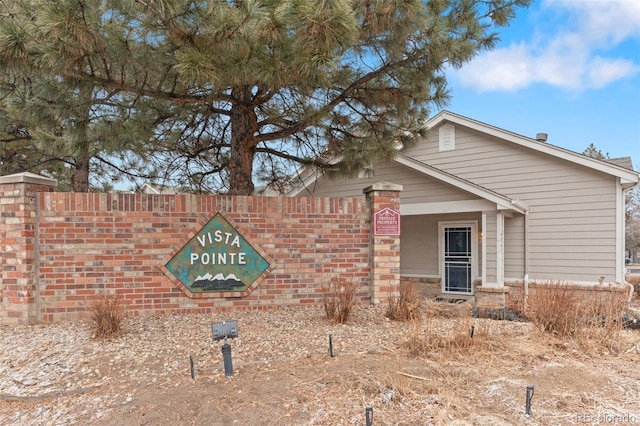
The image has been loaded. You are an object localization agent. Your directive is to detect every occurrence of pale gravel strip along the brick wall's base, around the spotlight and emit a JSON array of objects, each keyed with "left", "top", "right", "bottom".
[{"left": 0, "top": 307, "right": 403, "bottom": 424}]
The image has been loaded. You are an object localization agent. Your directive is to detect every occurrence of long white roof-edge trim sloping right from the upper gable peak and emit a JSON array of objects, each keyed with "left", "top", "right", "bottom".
[{"left": 425, "top": 111, "right": 640, "bottom": 188}]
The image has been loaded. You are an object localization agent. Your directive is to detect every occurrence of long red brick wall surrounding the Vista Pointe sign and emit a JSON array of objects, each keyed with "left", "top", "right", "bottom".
[{"left": 0, "top": 173, "right": 399, "bottom": 323}]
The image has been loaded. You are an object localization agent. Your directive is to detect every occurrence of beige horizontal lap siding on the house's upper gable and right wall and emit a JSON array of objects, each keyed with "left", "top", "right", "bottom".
[{"left": 405, "top": 126, "right": 617, "bottom": 282}]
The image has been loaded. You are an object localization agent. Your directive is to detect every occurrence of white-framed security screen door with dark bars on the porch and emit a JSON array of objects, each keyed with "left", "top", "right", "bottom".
[{"left": 442, "top": 224, "right": 473, "bottom": 294}]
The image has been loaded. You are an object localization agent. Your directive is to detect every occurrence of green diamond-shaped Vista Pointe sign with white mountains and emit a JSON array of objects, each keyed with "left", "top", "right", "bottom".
[{"left": 165, "top": 213, "right": 269, "bottom": 293}]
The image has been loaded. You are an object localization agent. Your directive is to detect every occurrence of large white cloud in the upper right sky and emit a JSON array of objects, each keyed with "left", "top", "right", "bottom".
[{"left": 456, "top": 0, "right": 640, "bottom": 91}]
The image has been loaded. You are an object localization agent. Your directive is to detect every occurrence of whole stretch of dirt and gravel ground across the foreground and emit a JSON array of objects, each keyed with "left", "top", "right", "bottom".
[{"left": 0, "top": 307, "right": 640, "bottom": 426}]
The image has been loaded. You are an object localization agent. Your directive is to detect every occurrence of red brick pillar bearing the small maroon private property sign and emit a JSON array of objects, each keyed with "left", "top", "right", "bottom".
[{"left": 363, "top": 182, "right": 402, "bottom": 305}]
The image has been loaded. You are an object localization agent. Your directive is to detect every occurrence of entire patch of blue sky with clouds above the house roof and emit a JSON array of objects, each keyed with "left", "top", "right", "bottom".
[{"left": 446, "top": 0, "right": 640, "bottom": 170}]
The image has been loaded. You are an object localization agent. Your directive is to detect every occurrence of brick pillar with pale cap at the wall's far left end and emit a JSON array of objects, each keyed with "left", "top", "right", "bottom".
[{"left": 0, "top": 173, "right": 57, "bottom": 324}]
